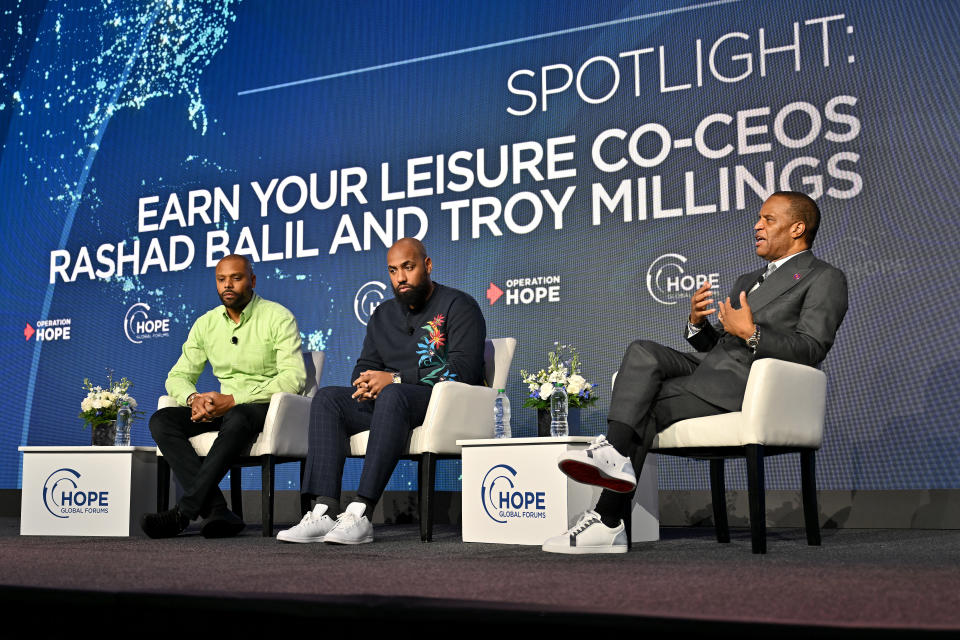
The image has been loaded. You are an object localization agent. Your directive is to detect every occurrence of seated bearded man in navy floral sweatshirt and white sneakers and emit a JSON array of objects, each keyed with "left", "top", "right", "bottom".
[{"left": 277, "top": 238, "right": 487, "bottom": 544}]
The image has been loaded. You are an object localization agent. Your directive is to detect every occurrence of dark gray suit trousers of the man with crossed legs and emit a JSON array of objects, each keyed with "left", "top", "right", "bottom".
[{"left": 597, "top": 340, "right": 727, "bottom": 520}]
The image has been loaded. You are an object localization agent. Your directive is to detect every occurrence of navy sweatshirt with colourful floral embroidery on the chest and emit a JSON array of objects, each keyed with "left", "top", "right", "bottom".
[{"left": 350, "top": 282, "right": 487, "bottom": 387}]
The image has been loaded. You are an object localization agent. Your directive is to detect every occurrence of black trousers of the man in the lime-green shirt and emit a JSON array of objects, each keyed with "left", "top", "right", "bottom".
[{"left": 150, "top": 403, "right": 270, "bottom": 520}]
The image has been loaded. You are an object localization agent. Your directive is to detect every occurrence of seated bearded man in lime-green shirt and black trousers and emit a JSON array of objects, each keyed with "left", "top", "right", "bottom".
[{"left": 140, "top": 255, "right": 307, "bottom": 538}]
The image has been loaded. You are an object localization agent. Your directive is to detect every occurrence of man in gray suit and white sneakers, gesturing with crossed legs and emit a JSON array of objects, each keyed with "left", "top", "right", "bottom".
[{"left": 543, "top": 191, "right": 847, "bottom": 553}]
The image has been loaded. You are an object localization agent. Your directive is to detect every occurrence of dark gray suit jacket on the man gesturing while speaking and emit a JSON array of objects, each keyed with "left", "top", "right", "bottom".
[{"left": 687, "top": 251, "right": 847, "bottom": 411}]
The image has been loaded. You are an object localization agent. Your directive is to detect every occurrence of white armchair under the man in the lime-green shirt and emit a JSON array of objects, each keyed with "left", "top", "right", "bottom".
[{"left": 157, "top": 351, "right": 325, "bottom": 537}]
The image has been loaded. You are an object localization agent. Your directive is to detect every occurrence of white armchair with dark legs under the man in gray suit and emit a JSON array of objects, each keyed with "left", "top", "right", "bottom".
[{"left": 651, "top": 358, "right": 827, "bottom": 553}]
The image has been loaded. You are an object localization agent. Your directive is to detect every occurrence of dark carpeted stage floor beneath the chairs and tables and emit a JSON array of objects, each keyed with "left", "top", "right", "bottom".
[{"left": 0, "top": 518, "right": 960, "bottom": 637}]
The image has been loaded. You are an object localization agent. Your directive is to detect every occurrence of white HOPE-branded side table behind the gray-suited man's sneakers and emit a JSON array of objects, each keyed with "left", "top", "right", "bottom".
[{"left": 457, "top": 436, "right": 660, "bottom": 545}]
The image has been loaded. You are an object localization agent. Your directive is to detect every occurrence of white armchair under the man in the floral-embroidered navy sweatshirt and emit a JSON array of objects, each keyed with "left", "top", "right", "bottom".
[{"left": 350, "top": 338, "right": 517, "bottom": 542}]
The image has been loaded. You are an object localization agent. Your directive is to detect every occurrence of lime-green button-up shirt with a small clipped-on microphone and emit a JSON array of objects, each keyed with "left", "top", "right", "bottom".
[{"left": 166, "top": 294, "right": 307, "bottom": 405}]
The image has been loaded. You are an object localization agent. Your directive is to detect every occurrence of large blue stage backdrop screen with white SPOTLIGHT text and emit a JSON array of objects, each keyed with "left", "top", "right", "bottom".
[{"left": 0, "top": 0, "right": 960, "bottom": 490}]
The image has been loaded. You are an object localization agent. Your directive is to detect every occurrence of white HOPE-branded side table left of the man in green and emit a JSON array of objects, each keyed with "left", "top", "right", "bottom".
[{"left": 20, "top": 447, "right": 157, "bottom": 536}]
